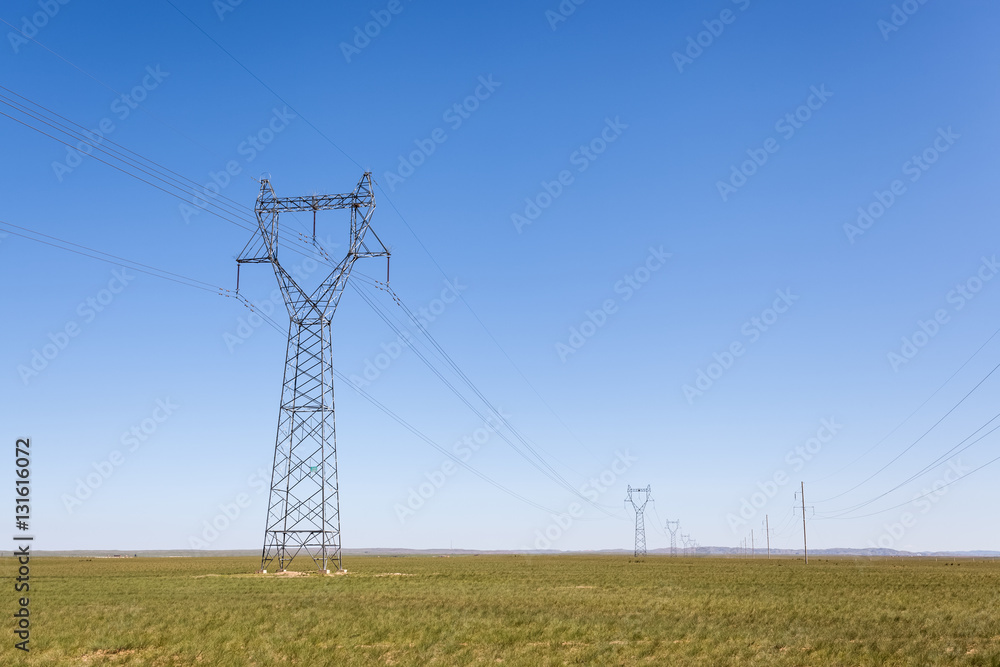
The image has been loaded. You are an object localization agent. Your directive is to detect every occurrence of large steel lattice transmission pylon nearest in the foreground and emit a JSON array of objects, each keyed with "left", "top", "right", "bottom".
[{"left": 236, "top": 172, "right": 389, "bottom": 572}]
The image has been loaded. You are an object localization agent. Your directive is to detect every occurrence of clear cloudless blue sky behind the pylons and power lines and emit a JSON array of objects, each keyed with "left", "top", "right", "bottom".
[{"left": 0, "top": 0, "right": 1000, "bottom": 550}]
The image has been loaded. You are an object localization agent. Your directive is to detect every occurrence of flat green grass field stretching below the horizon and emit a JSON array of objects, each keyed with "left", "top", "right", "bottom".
[{"left": 0, "top": 556, "right": 1000, "bottom": 666}]
